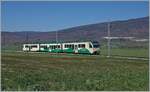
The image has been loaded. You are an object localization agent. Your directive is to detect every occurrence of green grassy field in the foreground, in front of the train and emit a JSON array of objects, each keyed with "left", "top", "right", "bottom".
[{"left": 1, "top": 52, "right": 149, "bottom": 91}]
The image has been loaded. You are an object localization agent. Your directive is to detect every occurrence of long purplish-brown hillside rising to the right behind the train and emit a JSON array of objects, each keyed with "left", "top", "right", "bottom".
[{"left": 1, "top": 17, "right": 149, "bottom": 45}]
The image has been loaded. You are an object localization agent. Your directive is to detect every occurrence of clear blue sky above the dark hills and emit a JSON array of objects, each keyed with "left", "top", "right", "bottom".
[{"left": 1, "top": 1, "right": 148, "bottom": 31}]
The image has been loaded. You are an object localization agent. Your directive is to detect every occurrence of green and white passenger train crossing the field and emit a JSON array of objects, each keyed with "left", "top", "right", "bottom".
[{"left": 23, "top": 42, "right": 100, "bottom": 54}]
